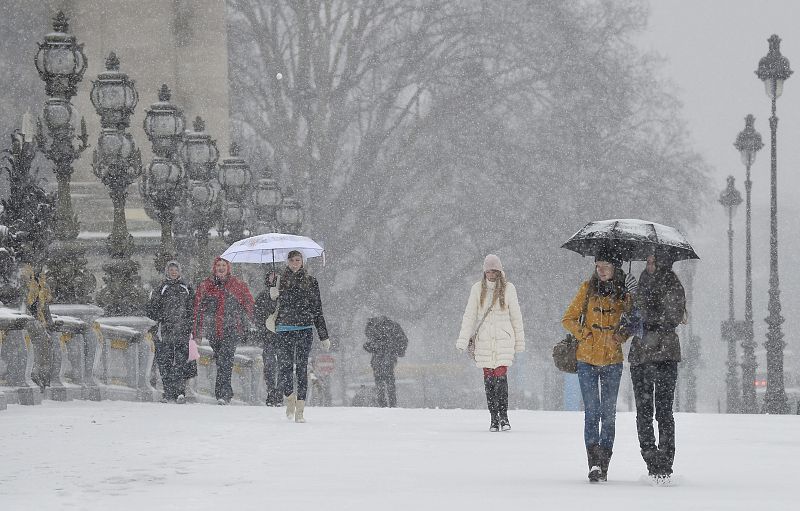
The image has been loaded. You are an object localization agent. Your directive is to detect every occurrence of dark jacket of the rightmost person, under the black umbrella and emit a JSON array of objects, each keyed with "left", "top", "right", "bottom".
[{"left": 628, "top": 268, "right": 686, "bottom": 365}]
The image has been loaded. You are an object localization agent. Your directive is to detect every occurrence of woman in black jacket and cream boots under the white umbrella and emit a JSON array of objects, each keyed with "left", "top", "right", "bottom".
[{"left": 269, "top": 250, "right": 331, "bottom": 422}]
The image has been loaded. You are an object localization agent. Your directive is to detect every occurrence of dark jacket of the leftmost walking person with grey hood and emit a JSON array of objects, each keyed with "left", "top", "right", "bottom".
[{"left": 147, "top": 278, "right": 194, "bottom": 343}]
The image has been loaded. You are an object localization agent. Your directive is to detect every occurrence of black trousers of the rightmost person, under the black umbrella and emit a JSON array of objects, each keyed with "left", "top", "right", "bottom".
[{"left": 631, "top": 362, "right": 678, "bottom": 474}]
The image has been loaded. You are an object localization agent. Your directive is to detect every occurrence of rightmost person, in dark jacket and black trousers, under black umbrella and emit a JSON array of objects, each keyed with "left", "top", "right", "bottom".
[{"left": 628, "top": 249, "right": 686, "bottom": 483}]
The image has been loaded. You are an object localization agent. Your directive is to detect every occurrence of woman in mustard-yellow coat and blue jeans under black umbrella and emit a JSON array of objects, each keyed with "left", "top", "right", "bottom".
[{"left": 561, "top": 247, "right": 631, "bottom": 482}]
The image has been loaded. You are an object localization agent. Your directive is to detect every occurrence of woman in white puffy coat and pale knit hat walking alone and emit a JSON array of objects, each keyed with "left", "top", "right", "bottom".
[{"left": 456, "top": 254, "right": 525, "bottom": 431}]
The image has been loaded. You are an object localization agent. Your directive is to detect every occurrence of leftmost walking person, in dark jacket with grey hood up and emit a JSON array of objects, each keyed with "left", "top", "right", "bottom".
[{"left": 147, "top": 261, "right": 197, "bottom": 404}]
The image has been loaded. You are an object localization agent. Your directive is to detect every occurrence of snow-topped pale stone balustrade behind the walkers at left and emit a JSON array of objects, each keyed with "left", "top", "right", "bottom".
[{"left": 0, "top": 305, "right": 266, "bottom": 410}]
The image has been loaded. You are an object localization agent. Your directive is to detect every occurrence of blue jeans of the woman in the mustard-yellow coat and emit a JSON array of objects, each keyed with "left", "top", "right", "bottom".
[{"left": 578, "top": 362, "right": 622, "bottom": 449}]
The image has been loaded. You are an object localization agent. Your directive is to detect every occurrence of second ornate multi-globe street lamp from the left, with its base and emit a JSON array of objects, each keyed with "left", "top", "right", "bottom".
[{"left": 90, "top": 52, "right": 146, "bottom": 316}]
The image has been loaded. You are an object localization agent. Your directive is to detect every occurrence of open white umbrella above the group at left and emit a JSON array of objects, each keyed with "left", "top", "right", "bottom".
[{"left": 221, "top": 232, "right": 325, "bottom": 264}]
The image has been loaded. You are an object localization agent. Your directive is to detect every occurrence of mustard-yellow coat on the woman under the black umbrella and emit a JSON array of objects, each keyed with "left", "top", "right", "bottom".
[{"left": 561, "top": 281, "right": 630, "bottom": 366}]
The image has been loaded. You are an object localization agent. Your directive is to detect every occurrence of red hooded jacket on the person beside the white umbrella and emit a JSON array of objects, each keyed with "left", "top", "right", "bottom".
[{"left": 194, "top": 257, "right": 254, "bottom": 340}]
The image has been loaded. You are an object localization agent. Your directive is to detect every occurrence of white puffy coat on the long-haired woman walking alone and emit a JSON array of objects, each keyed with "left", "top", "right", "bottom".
[{"left": 456, "top": 281, "right": 525, "bottom": 369}]
